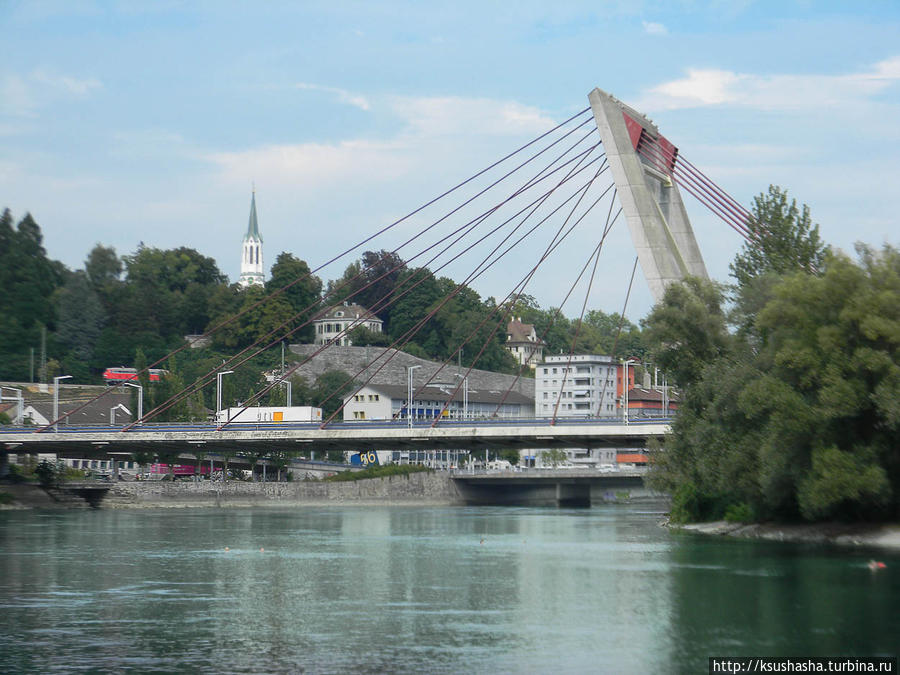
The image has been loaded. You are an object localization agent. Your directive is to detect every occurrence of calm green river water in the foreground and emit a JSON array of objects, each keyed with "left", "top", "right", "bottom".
[{"left": 0, "top": 505, "right": 900, "bottom": 674}]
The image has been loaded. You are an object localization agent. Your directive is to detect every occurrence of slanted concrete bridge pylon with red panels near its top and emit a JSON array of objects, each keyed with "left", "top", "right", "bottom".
[{"left": 588, "top": 89, "right": 707, "bottom": 302}]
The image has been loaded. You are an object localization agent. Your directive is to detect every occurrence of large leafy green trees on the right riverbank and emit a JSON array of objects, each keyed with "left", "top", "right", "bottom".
[{"left": 644, "top": 187, "right": 900, "bottom": 522}]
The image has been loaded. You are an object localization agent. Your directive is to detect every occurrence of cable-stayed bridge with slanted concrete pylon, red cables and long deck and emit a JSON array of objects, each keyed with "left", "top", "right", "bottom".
[{"left": 0, "top": 89, "right": 764, "bottom": 462}]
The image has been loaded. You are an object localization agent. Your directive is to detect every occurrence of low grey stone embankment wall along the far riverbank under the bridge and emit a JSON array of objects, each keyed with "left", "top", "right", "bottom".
[{"left": 100, "top": 472, "right": 460, "bottom": 508}]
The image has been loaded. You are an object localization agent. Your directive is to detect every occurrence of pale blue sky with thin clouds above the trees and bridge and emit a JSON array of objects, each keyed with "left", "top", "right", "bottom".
[{"left": 0, "top": 0, "right": 900, "bottom": 322}]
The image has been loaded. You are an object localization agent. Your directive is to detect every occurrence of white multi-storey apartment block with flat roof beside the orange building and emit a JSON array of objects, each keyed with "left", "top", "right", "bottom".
[{"left": 534, "top": 354, "right": 620, "bottom": 417}]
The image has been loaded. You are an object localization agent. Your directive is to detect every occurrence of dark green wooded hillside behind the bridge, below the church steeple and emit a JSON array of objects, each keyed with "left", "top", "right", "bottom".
[{"left": 0, "top": 209, "right": 644, "bottom": 421}]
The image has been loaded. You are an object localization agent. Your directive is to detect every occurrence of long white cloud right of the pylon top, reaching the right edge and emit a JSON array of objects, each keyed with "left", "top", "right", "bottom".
[{"left": 638, "top": 57, "right": 900, "bottom": 110}]
